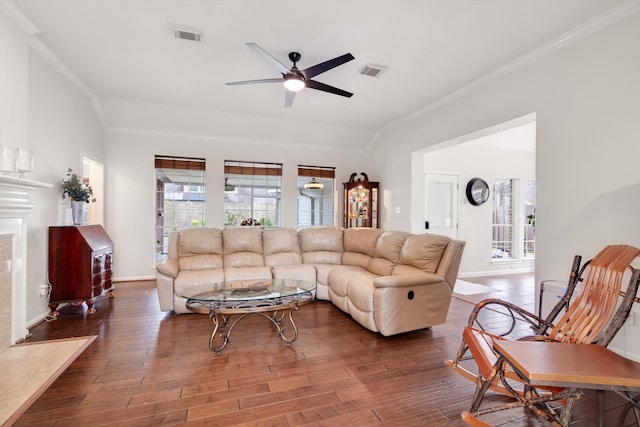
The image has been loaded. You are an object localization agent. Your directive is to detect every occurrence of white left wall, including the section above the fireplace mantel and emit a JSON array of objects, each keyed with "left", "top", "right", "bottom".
[{"left": 0, "top": 5, "right": 104, "bottom": 325}]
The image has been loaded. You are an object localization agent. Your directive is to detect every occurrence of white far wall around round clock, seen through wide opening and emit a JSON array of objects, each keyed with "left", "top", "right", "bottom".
[{"left": 411, "top": 113, "right": 536, "bottom": 275}]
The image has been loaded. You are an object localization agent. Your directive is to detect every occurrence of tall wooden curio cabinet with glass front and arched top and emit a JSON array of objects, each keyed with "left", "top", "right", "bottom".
[{"left": 343, "top": 172, "right": 379, "bottom": 228}]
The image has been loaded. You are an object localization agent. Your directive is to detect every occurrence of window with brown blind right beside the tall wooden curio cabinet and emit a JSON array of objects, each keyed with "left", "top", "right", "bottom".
[{"left": 298, "top": 165, "right": 335, "bottom": 228}]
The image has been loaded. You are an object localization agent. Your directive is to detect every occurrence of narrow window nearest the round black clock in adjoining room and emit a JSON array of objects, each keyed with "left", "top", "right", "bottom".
[{"left": 491, "top": 178, "right": 513, "bottom": 259}]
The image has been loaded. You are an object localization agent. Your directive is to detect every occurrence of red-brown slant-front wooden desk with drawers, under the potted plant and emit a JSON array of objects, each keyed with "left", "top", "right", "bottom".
[{"left": 48, "top": 225, "right": 113, "bottom": 317}]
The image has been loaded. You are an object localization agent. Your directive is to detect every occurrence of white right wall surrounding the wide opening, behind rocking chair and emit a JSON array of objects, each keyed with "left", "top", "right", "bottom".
[{"left": 372, "top": 13, "right": 640, "bottom": 356}]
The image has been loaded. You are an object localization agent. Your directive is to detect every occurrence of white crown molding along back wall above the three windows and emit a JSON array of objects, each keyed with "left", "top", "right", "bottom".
[{"left": 106, "top": 126, "right": 363, "bottom": 153}]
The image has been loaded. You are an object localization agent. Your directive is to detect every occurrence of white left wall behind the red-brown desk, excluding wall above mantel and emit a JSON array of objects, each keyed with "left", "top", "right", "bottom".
[{"left": 27, "top": 49, "right": 104, "bottom": 319}]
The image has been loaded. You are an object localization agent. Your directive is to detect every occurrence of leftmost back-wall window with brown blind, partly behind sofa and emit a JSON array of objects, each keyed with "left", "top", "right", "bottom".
[{"left": 155, "top": 156, "right": 205, "bottom": 261}]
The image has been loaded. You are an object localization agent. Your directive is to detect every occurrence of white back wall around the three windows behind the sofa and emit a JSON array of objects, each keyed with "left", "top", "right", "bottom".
[{"left": 106, "top": 132, "right": 376, "bottom": 280}]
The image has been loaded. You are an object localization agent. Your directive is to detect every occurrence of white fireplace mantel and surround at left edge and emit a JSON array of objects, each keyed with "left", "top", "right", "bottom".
[{"left": 0, "top": 175, "right": 53, "bottom": 349}]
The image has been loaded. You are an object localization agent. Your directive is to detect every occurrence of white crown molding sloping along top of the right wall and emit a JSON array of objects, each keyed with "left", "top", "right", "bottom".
[{"left": 380, "top": 0, "right": 640, "bottom": 134}]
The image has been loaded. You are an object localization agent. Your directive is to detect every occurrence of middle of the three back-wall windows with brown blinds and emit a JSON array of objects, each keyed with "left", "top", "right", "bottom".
[{"left": 224, "top": 160, "right": 282, "bottom": 227}]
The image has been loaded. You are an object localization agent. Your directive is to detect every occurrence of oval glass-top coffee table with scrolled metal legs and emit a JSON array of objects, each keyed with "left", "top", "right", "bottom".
[{"left": 180, "top": 279, "right": 316, "bottom": 354}]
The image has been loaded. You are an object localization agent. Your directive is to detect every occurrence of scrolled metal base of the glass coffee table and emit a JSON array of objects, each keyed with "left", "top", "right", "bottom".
[{"left": 209, "top": 307, "right": 298, "bottom": 354}]
